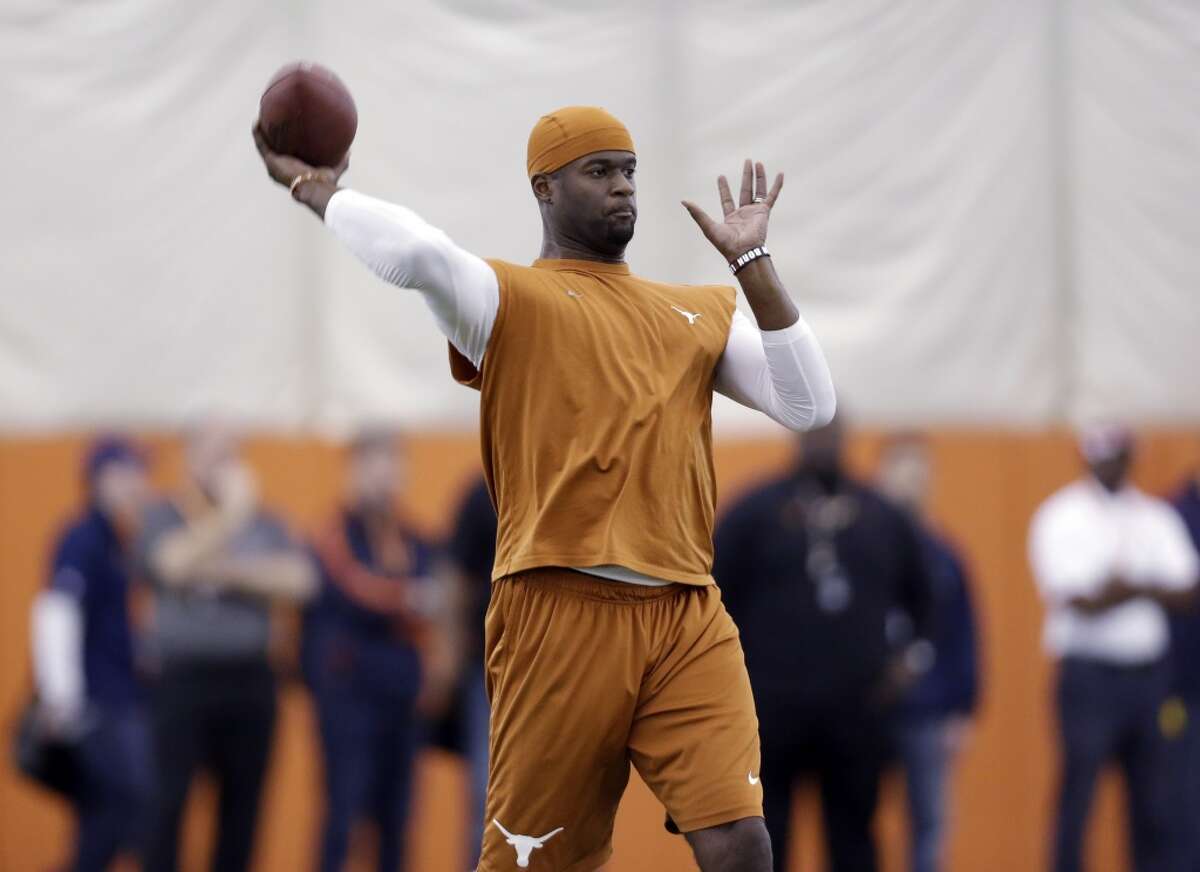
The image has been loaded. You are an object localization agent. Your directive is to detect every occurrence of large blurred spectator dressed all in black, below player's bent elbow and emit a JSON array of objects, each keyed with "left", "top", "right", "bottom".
[{"left": 714, "top": 417, "right": 932, "bottom": 872}]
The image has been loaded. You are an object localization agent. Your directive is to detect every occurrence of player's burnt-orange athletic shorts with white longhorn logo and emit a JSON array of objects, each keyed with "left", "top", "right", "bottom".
[{"left": 479, "top": 569, "right": 762, "bottom": 872}]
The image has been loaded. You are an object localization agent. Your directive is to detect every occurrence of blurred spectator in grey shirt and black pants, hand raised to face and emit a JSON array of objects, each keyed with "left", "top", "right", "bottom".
[{"left": 140, "top": 425, "right": 316, "bottom": 872}]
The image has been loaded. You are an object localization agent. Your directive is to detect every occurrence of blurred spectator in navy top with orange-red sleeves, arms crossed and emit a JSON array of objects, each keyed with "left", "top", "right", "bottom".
[{"left": 305, "top": 433, "right": 438, "bottom": 872}]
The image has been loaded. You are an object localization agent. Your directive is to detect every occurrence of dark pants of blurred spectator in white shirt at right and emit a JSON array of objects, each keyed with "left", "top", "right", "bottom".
[{"left": 1054, "top": 657, "right": 1174, "bottom": 872}]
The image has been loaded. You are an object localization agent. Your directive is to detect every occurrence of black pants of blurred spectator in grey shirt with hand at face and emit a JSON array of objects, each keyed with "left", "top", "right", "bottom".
[{"left": 144, "top": 661, "right": 275, "bottom": 872}]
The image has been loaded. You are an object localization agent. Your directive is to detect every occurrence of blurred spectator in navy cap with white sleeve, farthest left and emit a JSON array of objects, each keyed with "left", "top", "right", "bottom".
[{"left": 32, "top": 437, "right": 151, "bottom": 871}]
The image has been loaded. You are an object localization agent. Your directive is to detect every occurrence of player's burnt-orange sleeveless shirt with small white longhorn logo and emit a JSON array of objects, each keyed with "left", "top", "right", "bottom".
[{"left": 450, "top": 260, "right": 734, "bottom": 584}]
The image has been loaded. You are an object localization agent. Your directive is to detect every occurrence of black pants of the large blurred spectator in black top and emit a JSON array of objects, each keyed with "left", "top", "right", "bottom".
[{"left": 758, "top": 698, "right": 889, "bottom": 872}]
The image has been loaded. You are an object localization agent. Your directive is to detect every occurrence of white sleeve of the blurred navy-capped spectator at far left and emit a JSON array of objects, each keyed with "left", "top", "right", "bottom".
[{"left": 31, "top": 590, "right": 85, "bottom": 711}]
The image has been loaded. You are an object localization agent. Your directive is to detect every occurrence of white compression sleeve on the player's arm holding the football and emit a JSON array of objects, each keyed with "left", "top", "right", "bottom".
[{"left": 325, "top": 190, "right": 500, "bottom": 367}]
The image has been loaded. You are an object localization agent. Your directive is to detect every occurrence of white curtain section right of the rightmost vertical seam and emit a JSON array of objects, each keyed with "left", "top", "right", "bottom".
[{"left": 1066, "top": 0, "right": 1200, "bottom": 422}]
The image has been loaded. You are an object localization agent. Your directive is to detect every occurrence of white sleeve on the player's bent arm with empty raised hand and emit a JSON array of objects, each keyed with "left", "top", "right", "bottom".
[{"left": 716, "top": 312, "right": 838, "bottom": 431}]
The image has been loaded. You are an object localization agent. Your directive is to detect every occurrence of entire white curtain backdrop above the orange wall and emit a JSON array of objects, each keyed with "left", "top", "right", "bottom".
[{"left": 0, "top": 0, "right": 1200, "bottom": 433}]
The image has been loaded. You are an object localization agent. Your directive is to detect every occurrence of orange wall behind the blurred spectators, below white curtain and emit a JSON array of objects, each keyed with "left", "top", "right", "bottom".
[{"left": 0, "top": 432, "right": 1200, "bottom": 872}]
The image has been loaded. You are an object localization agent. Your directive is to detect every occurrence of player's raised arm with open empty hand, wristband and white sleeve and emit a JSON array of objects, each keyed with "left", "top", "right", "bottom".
[{"left": 684, "top": 161, "right": 836, "bottom": 431}]
